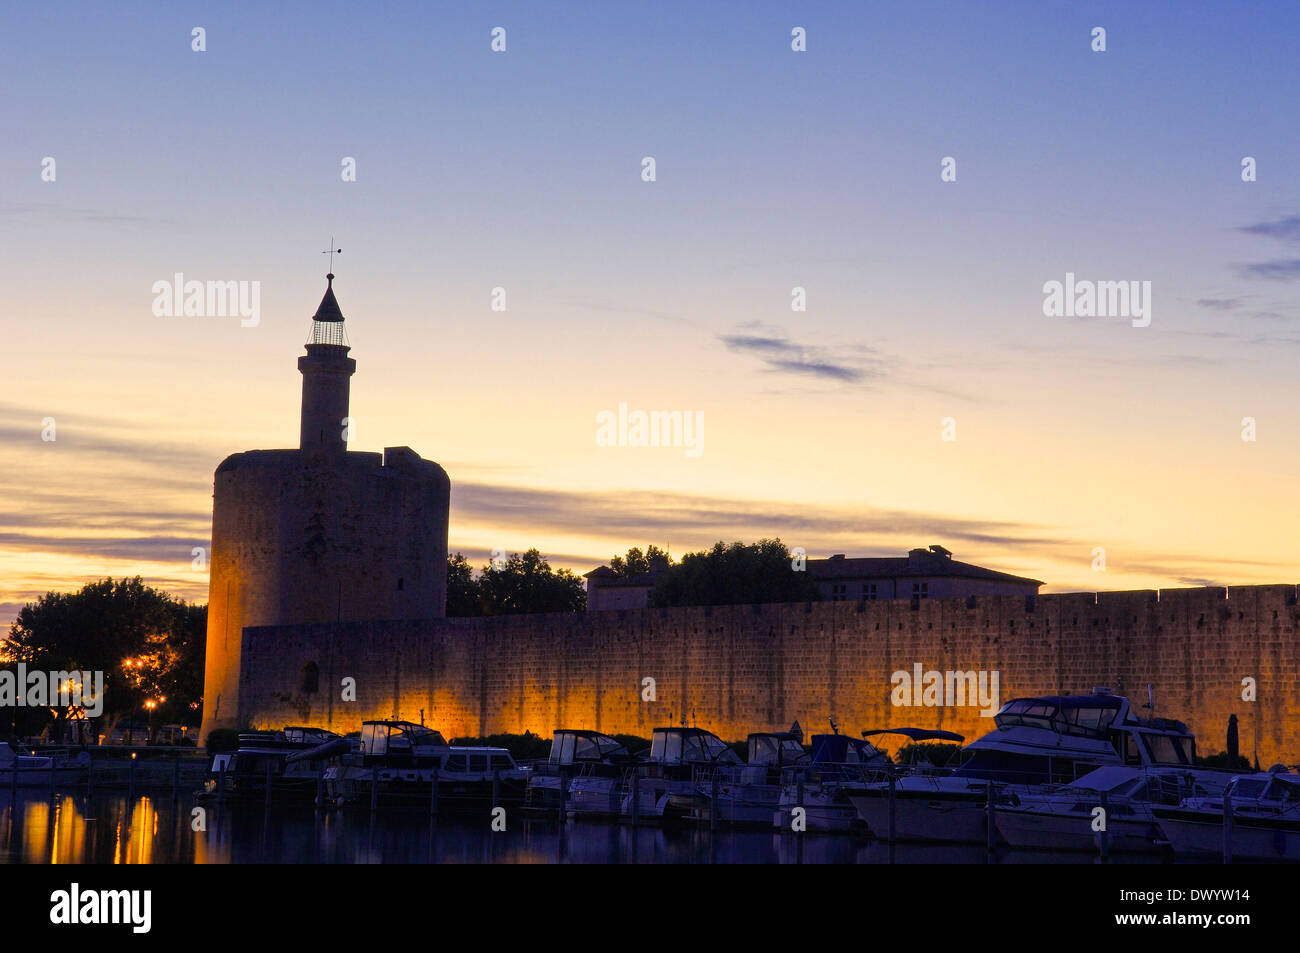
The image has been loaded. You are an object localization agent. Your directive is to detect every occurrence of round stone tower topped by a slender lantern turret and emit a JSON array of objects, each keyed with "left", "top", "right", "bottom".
[{"left": 200, "top": 274, "right": 451, "bottom": 744}]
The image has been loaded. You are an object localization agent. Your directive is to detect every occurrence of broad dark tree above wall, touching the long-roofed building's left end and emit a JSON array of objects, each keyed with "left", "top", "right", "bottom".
[{"left": 650, "top": 540, "right": 822, "bottom": 608}]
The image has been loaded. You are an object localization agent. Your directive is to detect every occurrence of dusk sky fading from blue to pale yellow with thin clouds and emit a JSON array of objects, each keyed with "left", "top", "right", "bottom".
[{"left": 0, "top": 0, "right": 1300, "bottom": 621}]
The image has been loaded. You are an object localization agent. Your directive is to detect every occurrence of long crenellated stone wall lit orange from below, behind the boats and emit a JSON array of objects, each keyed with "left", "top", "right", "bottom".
[{"left": 239, "top": 585, "right": 1300, "bottom": 767}]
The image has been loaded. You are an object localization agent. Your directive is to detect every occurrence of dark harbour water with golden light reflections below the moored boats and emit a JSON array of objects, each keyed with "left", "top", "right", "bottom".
[{"left": 0, "top": 794, "right": 1161, "bottom": 863}]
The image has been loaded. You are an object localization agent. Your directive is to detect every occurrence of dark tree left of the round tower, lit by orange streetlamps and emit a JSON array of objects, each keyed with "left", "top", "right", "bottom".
[{"left": 0, "top": 576, "right": 208, "bottom": 738}]
